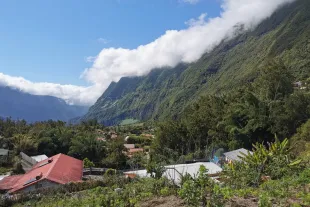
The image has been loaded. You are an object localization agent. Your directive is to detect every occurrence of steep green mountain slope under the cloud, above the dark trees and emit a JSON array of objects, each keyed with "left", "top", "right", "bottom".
[{"left": 81, "top": 0, "right": 310, "bottom": 125}]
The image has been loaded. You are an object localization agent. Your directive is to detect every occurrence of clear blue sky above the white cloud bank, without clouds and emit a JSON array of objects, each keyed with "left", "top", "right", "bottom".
[{"left": 0, "top": 0, "right": 220, "bottom": 86}]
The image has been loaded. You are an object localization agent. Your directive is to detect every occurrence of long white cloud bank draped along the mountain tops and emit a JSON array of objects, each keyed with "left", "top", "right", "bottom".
[{"left": 0, "top": 0, "right": 294, "bottom": 105}]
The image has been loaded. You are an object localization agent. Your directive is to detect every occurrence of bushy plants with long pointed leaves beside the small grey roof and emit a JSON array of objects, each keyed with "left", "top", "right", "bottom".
[{"left": 224, "top": 139, "right": 301, "bottom": 189}]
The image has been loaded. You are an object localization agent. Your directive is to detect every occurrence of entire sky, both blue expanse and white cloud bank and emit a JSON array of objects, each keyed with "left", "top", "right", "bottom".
[{"left": 0, "top": 0, "right": 294, "bottom": 105}]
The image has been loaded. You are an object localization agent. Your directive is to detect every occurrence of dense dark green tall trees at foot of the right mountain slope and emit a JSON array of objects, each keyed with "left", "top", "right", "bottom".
[{"left": 153, "top": 61, "right": 310, "bottom": 161}]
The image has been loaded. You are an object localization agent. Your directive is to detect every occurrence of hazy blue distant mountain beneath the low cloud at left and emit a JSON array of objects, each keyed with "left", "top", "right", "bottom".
[{"left": 0, "top": 86, "right": 88, "bottom": 122}]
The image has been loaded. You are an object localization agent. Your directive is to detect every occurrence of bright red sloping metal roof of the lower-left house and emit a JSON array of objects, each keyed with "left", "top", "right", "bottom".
[{"left": 0, "top": 154, "right": 83, "bottom": 193}]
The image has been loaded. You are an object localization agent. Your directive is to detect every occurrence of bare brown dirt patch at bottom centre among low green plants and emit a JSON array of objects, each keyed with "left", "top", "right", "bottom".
[{"left": 139, "top": 196, "right": 186, "bottom": 207}]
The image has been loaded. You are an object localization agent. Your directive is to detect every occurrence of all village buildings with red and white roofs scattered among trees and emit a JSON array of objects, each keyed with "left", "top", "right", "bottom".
[{"left": 0, "top": 133, "right": 252, "bottom": 196}]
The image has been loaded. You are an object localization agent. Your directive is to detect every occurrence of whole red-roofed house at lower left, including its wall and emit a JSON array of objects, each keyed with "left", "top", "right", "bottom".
[{"left": 0, "top": 154, "right": 83, "bottom": 194}]
